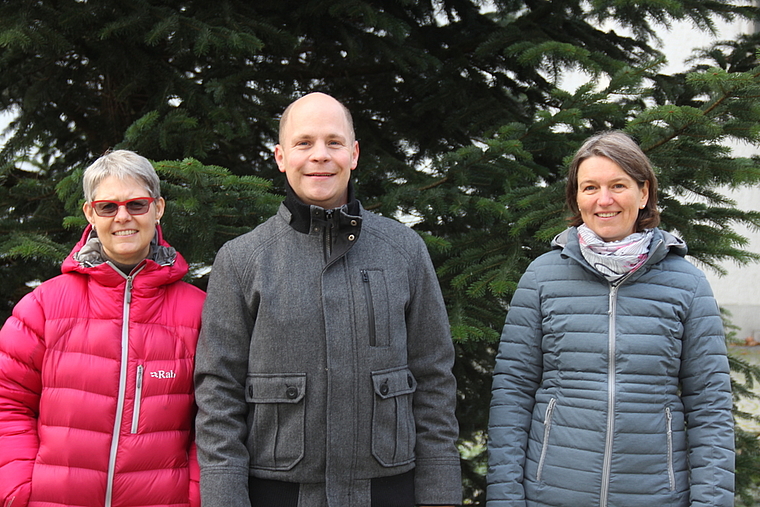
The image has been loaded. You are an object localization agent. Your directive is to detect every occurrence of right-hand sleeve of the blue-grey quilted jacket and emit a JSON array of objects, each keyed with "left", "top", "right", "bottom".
[{"left": 680, "top": 273, "right": 734, "bottom": 507}]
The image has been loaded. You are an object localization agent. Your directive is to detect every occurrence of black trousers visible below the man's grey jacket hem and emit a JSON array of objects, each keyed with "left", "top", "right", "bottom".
[{"left": 248, "top": 470, "right": 415, "bottom": 507}]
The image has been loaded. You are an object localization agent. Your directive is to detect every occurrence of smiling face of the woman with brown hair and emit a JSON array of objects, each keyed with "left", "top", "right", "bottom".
[{"left": 577, "top": 156, "right": 649, "bottom": 241}]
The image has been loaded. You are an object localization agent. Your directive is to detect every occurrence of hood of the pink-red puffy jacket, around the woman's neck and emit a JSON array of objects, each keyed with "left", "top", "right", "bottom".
[{"left": 61, "top": 225, "right": 189, "bottom": 285}]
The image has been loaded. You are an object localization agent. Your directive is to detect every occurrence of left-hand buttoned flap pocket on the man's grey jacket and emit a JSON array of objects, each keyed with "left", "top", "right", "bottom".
[{"left": 245, "top": 373, "right": 306, "bottom": 470}]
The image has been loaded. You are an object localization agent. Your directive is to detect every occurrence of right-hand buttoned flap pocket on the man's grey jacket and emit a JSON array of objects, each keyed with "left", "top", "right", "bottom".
[{"left": 372, "top": 367, "right": 417, "bottom": 467}]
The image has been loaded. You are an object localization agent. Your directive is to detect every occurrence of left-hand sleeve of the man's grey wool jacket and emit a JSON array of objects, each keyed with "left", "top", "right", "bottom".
[{"left": 195, "top": 243, "right": 253, "bottom": 507}]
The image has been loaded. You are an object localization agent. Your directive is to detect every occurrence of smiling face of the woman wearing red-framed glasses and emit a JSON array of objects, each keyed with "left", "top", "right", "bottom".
[{"left": 83, "top": 176, "right": 164, "bottom": 265}]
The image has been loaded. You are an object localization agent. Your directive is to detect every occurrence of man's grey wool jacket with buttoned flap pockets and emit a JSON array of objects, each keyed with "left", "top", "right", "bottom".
[{"left": 195, "top": 201, "right": 461, "bottom": 507}]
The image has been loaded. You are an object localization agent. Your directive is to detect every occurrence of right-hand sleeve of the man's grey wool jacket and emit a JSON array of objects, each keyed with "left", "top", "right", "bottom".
[{"left": 406, "top": 237, "right": 462, "bottom": 505}]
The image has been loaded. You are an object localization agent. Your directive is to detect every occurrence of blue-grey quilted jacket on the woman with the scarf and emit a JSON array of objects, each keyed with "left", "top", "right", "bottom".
[{"left": 487, "top": 228, "right": 734, "bottom": 507}]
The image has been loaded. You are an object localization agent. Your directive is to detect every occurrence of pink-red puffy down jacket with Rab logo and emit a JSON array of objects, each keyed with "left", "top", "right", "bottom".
[{"left": 0, "top": 227, "right": 204, "bottom": 507}]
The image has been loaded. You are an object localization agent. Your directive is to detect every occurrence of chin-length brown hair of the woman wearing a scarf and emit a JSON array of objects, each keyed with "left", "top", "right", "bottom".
[{"left": 565, "top": 130, "right": 660, "bottom": 232}]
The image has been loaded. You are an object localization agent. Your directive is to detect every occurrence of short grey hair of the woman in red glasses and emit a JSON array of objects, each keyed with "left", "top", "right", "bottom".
[{"left": 82, "top": 150, "right": 161, "bottom": 202}]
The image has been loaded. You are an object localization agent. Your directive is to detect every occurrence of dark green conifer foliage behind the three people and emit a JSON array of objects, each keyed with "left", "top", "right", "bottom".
[{"left": 0, "top": 0, "right": 760, "bottom": 503}]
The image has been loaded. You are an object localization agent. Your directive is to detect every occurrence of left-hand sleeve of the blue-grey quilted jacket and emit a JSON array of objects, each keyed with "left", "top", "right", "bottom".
[{"left": 487, "top": 266, "right": 543, "bottom": 507}]
